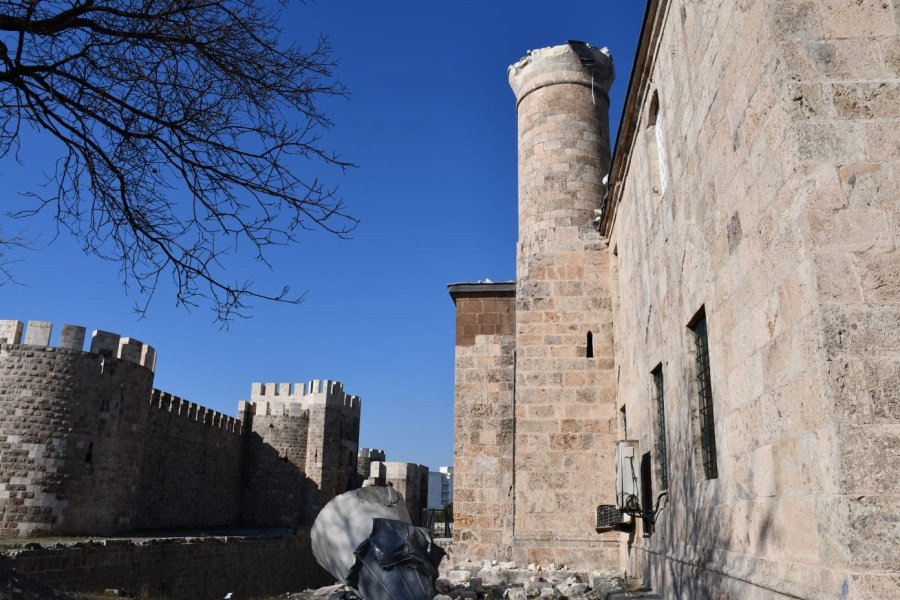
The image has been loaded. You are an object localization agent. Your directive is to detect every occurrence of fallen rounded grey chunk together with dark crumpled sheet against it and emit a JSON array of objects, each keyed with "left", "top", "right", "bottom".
[{"left": 312, "top": 486, "right": 444, "bottom": 600}]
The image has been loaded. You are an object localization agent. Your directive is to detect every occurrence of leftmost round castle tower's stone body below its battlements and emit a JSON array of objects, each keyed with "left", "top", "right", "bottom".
[{"left": 0, "top": 342, "right": 153, "bottom": 535}]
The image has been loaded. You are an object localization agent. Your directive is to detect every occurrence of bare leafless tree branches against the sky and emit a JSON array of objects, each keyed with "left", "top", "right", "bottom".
[{"left": 0, "top": 0, "right": 356, "bottom": 321}]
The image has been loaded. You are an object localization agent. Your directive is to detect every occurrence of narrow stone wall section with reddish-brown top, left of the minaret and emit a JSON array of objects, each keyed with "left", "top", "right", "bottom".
[{"left": 450, "top": 283, "right": 516, "bottom": 560}]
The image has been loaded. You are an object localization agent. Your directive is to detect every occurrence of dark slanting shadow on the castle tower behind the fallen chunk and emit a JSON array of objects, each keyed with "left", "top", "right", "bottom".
[{"left": 241, "top": 432, "right": 321, "bottom": 528}]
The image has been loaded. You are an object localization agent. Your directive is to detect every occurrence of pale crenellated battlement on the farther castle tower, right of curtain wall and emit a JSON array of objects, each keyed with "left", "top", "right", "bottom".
[{"left": 250, "top": 379, "right": 362, "bottom": 415}]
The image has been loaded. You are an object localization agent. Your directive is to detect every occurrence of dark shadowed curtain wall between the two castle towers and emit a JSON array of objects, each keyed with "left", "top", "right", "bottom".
[{"left": 137, "top": 390, "right": 243, "bottom": 529}]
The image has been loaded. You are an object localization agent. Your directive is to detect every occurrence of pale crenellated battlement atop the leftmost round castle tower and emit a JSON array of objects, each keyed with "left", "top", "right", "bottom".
[{"left": 0, "top": 320, "right": 156, "bottom": 372}]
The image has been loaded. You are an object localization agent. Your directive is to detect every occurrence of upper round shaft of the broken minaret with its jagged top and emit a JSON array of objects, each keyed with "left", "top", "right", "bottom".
[{"left": 509, "top": 42, "right": 613, "bottom": 268}]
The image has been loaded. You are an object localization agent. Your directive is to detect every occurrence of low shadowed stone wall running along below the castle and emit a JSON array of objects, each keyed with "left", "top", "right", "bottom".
[{"left": 4, "top": 529, "right": 334, "bottom": 600}]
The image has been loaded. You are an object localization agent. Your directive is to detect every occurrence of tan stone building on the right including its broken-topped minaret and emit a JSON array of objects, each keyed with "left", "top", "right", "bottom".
[{"left": 450, "top": 0, "right": 900, "bottom": 599}]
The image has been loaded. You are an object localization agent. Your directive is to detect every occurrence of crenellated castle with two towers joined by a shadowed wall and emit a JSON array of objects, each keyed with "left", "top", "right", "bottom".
[{"left": 0, "top": 321, "right": 360, "bottom": 536}]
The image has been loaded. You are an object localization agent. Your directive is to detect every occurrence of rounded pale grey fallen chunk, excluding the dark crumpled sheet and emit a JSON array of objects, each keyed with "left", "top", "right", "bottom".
[{"left": 311, "top": 486, "right": 412, "bottom": 584}]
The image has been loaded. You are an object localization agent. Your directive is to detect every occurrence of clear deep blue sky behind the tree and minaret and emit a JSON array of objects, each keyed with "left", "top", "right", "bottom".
[{"left": 0, "top": 0, "right": 644, "bottom": 469}]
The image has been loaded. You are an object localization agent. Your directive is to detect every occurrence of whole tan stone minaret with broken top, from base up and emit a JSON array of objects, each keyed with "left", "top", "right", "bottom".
[{"left": 509, "top": 42, "right": 618, "bottom": 567}]
